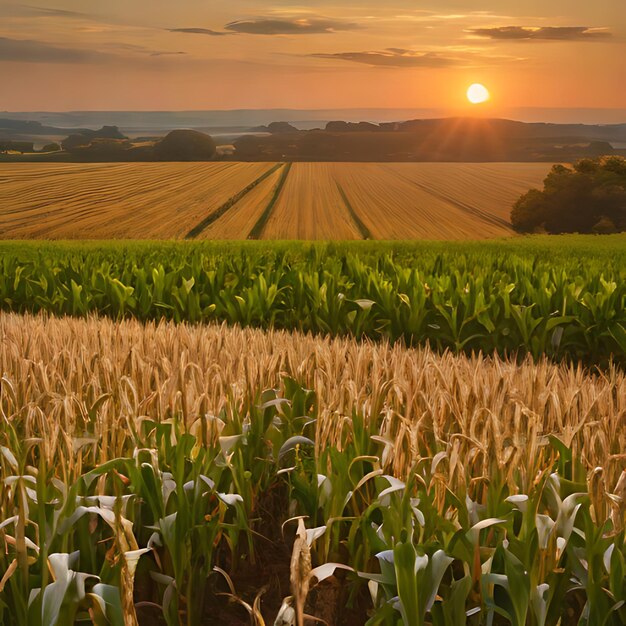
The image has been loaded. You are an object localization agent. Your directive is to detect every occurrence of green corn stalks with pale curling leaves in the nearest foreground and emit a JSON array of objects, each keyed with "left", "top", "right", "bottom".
[{"left": 0, "top": 370, "right": 626, "bottom": 626}]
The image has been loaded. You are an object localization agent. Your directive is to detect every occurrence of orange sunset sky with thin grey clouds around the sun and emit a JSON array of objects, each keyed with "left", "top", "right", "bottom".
[{"left": 0, "top": 0, "right": 626, "bottom": 116}]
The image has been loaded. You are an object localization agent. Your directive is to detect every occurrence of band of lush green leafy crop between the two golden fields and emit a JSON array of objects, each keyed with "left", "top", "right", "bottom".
[{"left": 0, "top": 240, "right": 626, "bottom": 363}]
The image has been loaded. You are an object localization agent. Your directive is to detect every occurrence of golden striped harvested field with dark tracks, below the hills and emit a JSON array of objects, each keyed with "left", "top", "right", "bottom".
[{"left": 0, "top": 163, "right": 550, "bottom": 240}]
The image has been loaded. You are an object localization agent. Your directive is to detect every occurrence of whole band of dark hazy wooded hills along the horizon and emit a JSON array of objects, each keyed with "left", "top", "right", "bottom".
[{"left": 0, "top": 117, "right": 626, "bottom": 162}]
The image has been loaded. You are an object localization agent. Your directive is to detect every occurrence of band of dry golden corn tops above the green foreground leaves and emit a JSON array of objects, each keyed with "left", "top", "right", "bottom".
[{"left": 0, "top": 313, "right": 626, "bottom": 489}]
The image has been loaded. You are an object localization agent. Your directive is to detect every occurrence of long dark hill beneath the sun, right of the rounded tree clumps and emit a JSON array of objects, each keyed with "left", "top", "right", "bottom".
[{"left": 234, "top": 118, "right": 626, "bottom": 161}]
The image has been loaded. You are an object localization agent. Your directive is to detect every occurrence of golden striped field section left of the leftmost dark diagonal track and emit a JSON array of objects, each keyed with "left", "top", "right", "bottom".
[{"left": 0, "top": 163, "right": 272, "bottom": 239}]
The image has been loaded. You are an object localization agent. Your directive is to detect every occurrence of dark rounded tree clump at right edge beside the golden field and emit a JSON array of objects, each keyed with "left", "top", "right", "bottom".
[{"left": 511, "top": 156, "right": 626, "bottom": 233}]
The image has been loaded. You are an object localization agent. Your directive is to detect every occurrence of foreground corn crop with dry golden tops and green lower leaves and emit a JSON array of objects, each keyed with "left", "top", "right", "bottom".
[{"left": 0, "top": 313, "right": 626, "bottom": 626}]
